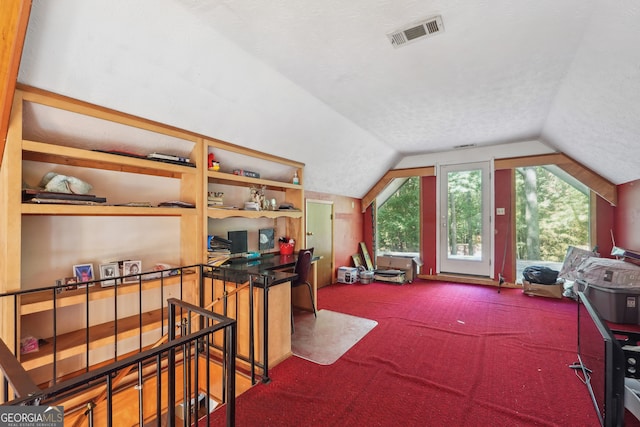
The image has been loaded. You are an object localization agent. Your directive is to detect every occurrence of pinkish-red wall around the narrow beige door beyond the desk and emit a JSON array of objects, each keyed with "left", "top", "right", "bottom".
[{"left": 304, "top": 191, "right": 364, "bottom": 274}]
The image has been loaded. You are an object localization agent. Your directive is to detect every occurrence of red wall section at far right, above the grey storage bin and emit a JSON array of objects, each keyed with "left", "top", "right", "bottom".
[{"left": 614, "top": 180, "right": 640, "bottom": 251}]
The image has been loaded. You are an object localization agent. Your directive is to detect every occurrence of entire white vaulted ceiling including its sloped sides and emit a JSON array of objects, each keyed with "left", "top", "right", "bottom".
[{"left": 13, "top": 0, "right": 640, "bottom": 197}]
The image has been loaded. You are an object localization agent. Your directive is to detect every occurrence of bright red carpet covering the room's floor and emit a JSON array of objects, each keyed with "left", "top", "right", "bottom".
[{"left": 204, "top": 281, "right": 640, "bottom": 426}]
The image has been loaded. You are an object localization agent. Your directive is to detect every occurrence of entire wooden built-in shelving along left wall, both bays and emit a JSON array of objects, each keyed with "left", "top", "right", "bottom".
[{"left": 0, "top": 87, "right": 304, "bottom": 386}]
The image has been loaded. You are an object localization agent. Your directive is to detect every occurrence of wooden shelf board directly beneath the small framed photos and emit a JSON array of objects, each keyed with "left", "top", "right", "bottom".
[{"left": 20, "top": 273, "right": 197, "bottom": 316}]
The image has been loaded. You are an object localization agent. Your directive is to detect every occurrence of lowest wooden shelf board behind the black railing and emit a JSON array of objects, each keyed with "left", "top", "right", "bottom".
[{"left": 20, "top": 308, "right": 176, "bottom": 371}]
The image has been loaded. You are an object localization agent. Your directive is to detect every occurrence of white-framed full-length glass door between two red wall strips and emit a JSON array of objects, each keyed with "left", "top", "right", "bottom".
[{"left": 438, "top": 162, "right": 493, "bottom": 277}]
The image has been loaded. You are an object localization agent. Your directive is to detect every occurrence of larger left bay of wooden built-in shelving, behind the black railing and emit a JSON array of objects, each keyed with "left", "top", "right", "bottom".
[{"left": 0, "top": 88, "right": 205, "bottom": 381}]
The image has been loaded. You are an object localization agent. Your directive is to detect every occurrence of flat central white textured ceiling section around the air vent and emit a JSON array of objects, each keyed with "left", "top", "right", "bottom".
[{"left": 177, "top": 0, "right": 593, "bottom": 154}]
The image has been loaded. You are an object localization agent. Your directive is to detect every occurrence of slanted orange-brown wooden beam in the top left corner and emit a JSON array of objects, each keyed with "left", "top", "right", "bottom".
[{"left": 0, "top": 0, "right": 31, "bottom": 170}]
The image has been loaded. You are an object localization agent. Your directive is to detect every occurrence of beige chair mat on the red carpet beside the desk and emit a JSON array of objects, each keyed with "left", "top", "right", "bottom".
[{"left": 291, "top": 310, "right": 378, "bottom": 365}]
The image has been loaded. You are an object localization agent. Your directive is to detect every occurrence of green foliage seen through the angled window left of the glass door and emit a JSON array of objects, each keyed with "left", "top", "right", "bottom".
[{"left": 377, "top": 177, "right": 420, "bottom": 252}]
